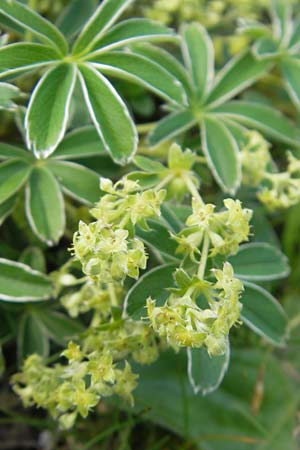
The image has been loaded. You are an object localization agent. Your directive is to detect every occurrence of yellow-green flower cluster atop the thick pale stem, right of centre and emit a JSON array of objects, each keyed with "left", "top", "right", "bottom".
[{"left": 173, "top": 198, "right": 252, "bottom": 259}]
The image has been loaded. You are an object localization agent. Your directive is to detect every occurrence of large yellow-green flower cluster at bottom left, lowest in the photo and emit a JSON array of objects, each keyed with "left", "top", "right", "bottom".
[{"left": 12, "top": 321, "right": 158, "bottom": 428}]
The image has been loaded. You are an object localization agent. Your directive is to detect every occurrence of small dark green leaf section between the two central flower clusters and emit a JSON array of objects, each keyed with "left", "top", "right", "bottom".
[{"left": 136, "top": 219, "right": 178, "bottom": 260}]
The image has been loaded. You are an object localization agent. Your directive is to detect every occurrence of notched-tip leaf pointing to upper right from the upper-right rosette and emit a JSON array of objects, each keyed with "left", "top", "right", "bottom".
[{"left": 207, "top": 51, "right": 270, "bottom": 106}]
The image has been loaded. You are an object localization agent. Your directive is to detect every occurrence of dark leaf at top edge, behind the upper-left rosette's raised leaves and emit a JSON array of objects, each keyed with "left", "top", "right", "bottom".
[{"left": 56, "top": 0, "right": 98, "bottom": 38}]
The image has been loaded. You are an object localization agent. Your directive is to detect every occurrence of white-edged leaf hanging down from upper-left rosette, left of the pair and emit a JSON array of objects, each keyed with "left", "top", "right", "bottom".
[{"left": 25, "top": 64, "right": 76, "bottom": 158}]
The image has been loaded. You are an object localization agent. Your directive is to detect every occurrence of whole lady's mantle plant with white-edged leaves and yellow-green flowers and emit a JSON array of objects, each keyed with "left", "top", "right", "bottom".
[{"left": 0, "top": 0, "right": 300, "bottom": 436}]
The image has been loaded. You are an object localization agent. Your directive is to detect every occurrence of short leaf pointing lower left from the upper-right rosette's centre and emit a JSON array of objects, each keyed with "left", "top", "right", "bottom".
[{"left": 148, "top": 110, "right": 198, "bottom": 146}]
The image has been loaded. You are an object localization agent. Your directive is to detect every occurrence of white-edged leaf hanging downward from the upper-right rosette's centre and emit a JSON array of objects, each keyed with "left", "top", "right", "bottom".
[{"left": 201, "top": 116, "right": 241, "bottom": 194}]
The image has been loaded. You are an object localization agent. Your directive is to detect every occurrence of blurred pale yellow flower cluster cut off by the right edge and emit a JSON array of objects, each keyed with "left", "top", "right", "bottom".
[{"left": 241, "top": 132, "right": 300, "bottom": 211}]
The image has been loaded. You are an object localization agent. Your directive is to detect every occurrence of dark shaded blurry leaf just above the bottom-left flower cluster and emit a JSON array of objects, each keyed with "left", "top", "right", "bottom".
[{"left": 39, "top": 310, "right": 83, "bottom": 344}]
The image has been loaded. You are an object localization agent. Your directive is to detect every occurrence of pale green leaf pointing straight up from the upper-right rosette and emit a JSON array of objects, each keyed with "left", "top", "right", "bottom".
[{"left": 181, "top": 23, "right": 214, "bottom": 99}]
